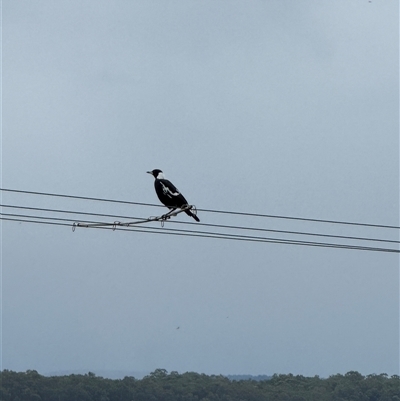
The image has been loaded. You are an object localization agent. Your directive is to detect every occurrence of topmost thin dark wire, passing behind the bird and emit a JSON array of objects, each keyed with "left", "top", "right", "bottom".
[{"left": 0, "top": 188, "right": 400, "bottom": 230}]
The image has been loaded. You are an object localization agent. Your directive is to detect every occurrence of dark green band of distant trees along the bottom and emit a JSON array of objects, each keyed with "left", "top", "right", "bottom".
[{"left": 0, "top": 369, "right": 400, "bottom": 401}]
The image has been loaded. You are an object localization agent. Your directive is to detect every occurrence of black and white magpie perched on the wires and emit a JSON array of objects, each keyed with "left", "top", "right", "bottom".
[{"left": 147, "top": 169, "right": 200, "bottom": 221}]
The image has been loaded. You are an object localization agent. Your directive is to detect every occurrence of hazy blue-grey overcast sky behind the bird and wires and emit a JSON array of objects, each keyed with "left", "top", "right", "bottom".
[{"left": 1, "top": 0, "right": 399, "bottom": 376}]
